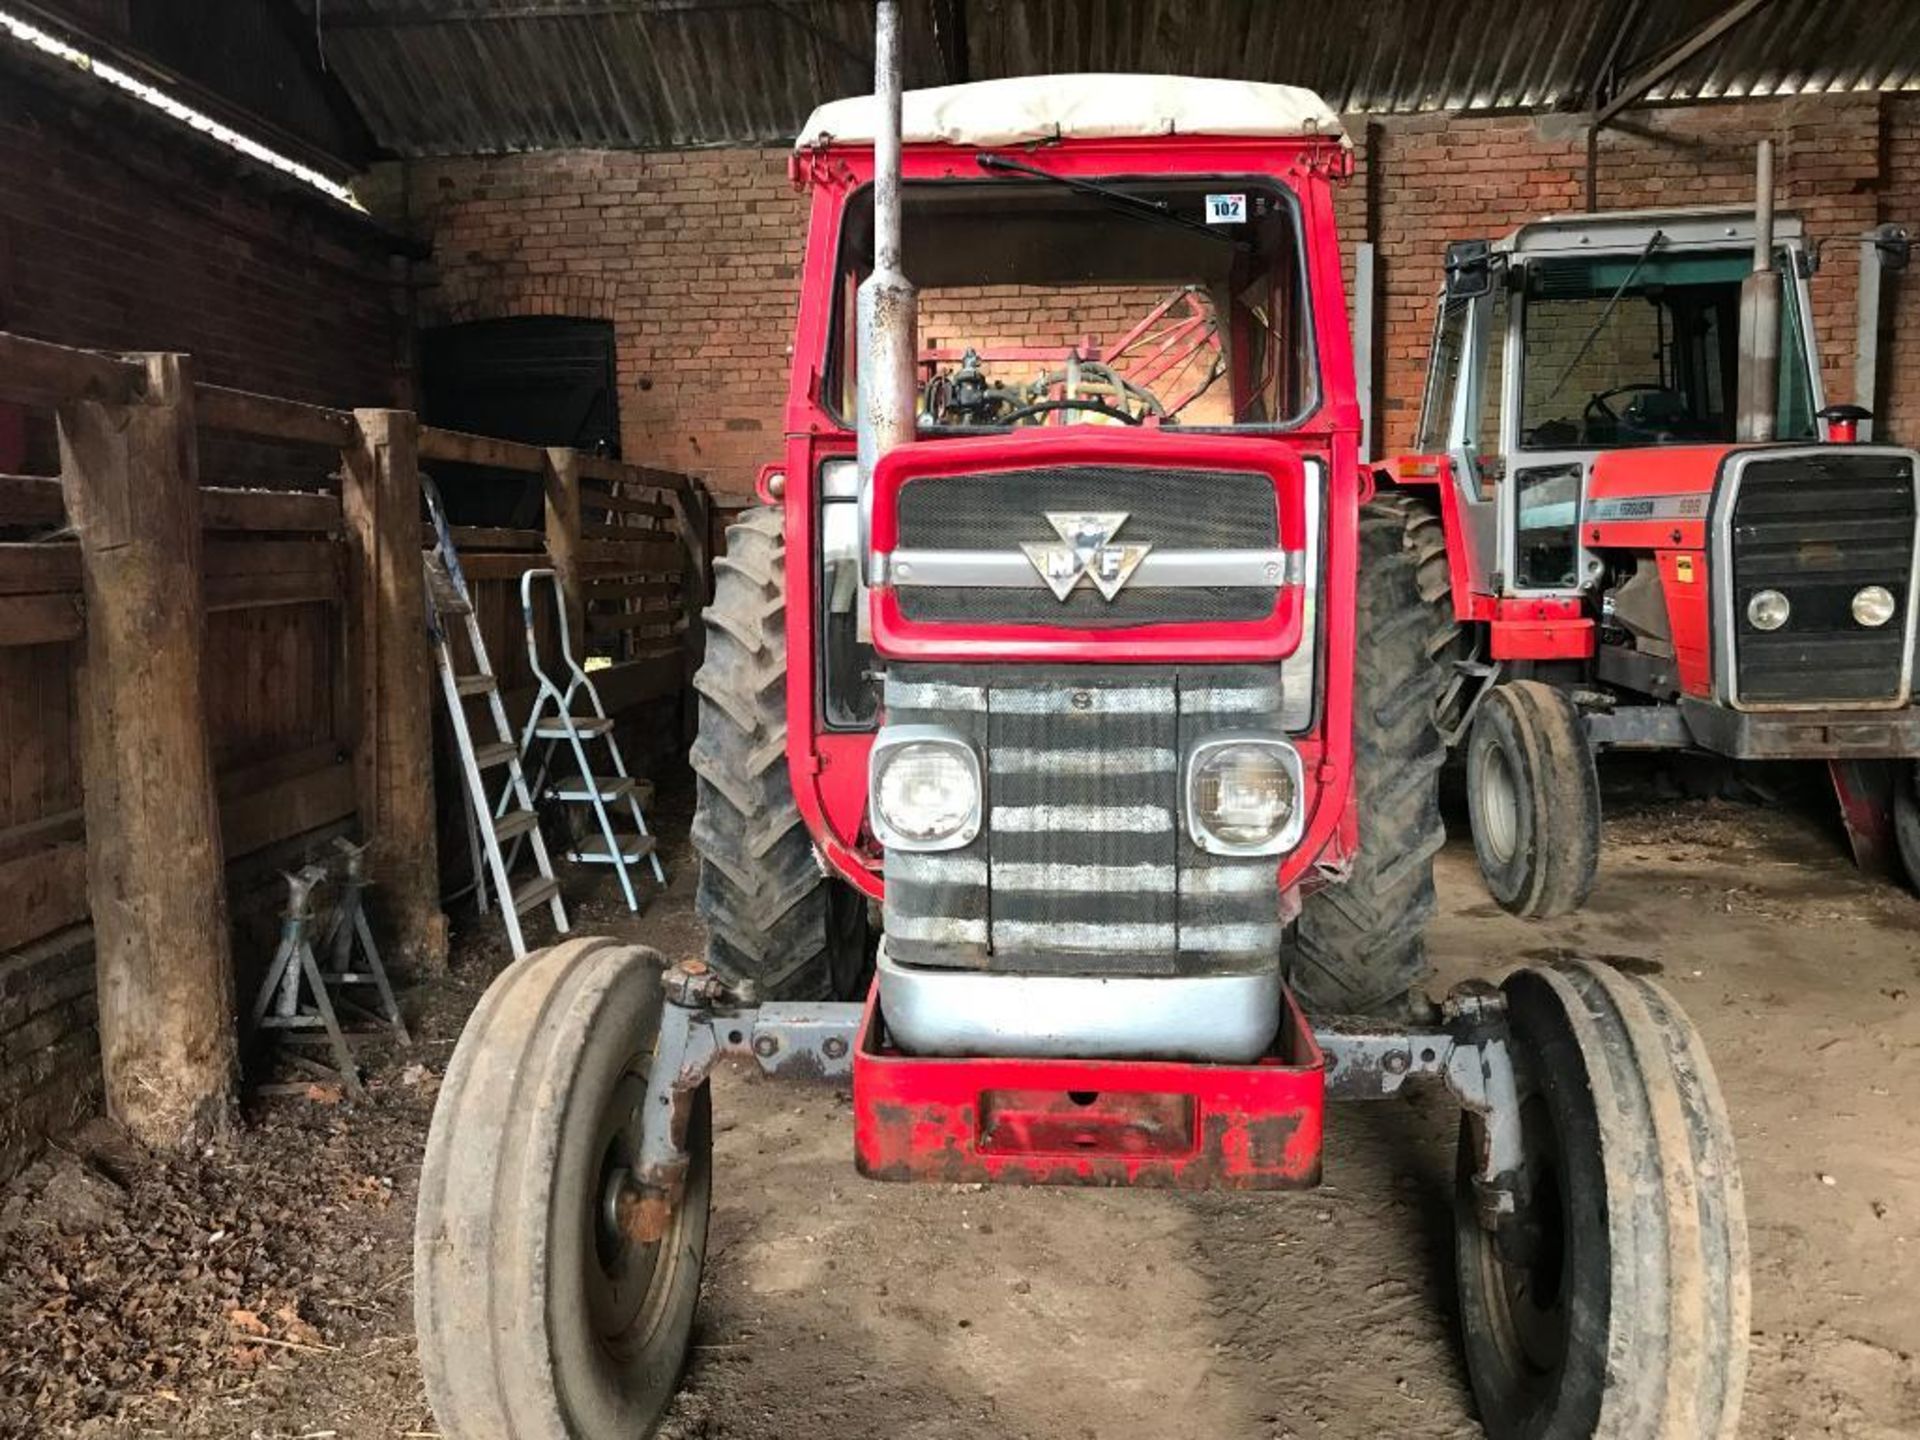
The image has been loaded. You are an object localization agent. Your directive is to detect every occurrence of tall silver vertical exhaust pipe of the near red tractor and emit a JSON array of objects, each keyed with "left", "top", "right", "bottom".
[{"left": 856, "top": 0, "right": 920, "bottom": 503}]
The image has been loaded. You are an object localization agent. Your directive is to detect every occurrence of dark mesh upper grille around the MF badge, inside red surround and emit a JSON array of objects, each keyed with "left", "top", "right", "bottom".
[{"left": 899, "top": 465, "right": 1279, "bottom": 630}]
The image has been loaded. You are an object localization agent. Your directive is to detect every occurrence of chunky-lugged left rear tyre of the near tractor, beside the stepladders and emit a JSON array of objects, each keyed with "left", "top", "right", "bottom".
[{"left": 691, "top": 505, "right": 868, "bottom": 1000}]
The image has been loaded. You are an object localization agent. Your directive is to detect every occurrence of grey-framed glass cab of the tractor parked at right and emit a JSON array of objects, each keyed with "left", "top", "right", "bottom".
[{"left": 1415, "top": 207, "right": 1826, "bottom": 597}]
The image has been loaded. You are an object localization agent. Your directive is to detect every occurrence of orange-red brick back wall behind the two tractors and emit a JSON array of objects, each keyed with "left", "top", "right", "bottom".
[{"left": 401, "top": 96, "right": 1920, "bottom": 492}]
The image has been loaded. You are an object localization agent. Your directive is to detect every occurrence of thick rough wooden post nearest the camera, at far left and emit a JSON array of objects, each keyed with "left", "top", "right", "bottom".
[{"left": 60, "top": 355, "right": 236, "bottom": 1146}]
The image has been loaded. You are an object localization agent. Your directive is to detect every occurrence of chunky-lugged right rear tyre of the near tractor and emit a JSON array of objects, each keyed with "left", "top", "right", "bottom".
[{"left": 1290, "top": 492, "right": 1459, "bottom": 1014}]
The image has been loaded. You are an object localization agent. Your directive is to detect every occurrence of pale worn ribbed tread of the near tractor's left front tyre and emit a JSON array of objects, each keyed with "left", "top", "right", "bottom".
[{"left": 413, "top": 937, "right": 705, "bottom": 1440}]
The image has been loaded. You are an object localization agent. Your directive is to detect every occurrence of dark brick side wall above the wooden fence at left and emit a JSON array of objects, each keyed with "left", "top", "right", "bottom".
[{"left": 0, "top": 69, "right": 403, "bottom": 484}]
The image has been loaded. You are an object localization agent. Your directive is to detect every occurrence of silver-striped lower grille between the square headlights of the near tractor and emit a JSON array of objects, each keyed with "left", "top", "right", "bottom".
[{"left": 885, "top": 664, "right": 1281, "bottom": 975}]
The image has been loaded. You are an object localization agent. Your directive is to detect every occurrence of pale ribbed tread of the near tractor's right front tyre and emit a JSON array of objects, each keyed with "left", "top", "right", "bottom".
[{"left": 1490, "top": 962, "right": 1753, "bottom": 1440}]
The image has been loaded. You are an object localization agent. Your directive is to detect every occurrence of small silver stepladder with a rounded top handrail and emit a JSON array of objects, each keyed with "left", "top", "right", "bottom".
[{"left": 510, "top": 570, "right": 666, "bottom": 912}]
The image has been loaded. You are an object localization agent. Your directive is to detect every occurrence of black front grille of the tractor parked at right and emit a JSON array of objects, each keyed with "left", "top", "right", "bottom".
[{"left": 1730, "top": 447, "right": 1914, "bottom": 705}]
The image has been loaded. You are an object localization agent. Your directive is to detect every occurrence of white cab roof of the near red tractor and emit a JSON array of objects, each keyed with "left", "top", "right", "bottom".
[{"left": 793, "top": 75, "right": 1352, "bottom": 150}]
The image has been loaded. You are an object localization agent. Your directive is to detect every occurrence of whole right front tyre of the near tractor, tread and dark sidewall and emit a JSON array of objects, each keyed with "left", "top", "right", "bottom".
[{"left": 1455, "top": 962, "right": 1751, "bottom": 1440}]
